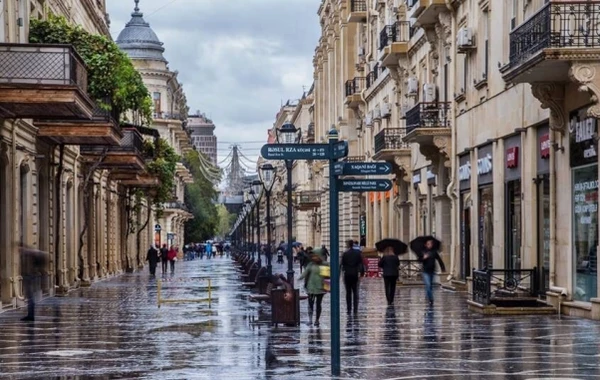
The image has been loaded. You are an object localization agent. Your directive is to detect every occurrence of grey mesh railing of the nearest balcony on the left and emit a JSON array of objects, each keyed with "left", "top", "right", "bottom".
[{"left": 0, "top": 44, "right": 88, "bottom": 93}]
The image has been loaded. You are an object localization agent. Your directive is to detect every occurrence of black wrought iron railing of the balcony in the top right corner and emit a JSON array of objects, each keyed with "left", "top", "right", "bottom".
[{"left": 509, "top": 0, "right": 600, "bottom": 67}]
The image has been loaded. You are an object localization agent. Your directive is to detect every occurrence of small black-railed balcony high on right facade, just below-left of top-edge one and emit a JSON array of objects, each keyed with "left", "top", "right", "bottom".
[{"left": 379, "top": 21, "right": 413, "bottom": 67}]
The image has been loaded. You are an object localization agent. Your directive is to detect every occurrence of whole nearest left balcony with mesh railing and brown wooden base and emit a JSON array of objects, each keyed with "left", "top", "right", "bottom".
[{"left": 0, "top": 44, "right": 94, "bottom": 120}]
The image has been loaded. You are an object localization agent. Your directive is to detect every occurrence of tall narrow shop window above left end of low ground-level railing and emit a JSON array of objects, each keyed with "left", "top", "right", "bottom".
[{"left": 479, "top": 186, "right": 494, "bottom": 269}]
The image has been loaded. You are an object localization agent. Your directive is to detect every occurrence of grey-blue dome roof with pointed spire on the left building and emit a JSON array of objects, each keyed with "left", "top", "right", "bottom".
[{"left": 117, "top": 0, "right": 167, "bottom": 62}]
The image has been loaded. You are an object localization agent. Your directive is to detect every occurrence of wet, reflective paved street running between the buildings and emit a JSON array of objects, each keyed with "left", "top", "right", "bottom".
[{"left": 0, "top": 258, "right": 600, "bottom": 380}]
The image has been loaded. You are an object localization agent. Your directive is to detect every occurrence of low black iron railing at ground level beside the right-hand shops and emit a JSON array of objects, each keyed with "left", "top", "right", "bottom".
[{"left": 473, "top": 267, "right": 538, "bottom": 305}]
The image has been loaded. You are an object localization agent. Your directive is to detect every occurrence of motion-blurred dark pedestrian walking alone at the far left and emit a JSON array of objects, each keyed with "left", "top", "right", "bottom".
[{"left": 20, "top": 246, "right": 48, "bottom": 321}]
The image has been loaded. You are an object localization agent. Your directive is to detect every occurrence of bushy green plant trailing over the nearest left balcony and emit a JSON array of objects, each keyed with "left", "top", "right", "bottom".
[{"left": 29, "top": 15, "right": 152, "bottom": 124}]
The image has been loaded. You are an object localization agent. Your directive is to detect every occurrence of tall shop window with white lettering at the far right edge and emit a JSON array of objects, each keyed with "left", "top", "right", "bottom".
[{"left": 573, "top": 165, "right": 598, "bottom": 302}]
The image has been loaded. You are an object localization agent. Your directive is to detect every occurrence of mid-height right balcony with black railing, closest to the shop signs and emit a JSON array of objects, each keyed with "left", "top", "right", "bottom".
[{"left": 404, "top": 102, "right": 452, "bottom": 161}]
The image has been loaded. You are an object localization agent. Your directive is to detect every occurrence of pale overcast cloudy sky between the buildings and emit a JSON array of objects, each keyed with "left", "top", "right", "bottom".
[{"left": 107, "top": 0, "right": 321, "bottom": 168}]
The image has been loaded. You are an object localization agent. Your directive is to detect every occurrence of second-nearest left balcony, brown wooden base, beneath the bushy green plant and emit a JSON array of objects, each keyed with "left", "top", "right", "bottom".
[{"left": 34, "top": 102, "right": 123, "bottom": 146}]
